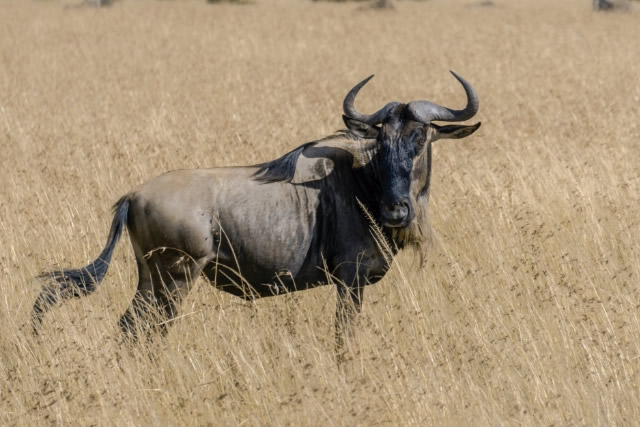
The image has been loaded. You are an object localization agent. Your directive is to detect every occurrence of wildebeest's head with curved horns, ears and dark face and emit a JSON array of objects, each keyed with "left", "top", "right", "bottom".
[{"left": 343, "top": 72, "right": 480, "bottom": 232}]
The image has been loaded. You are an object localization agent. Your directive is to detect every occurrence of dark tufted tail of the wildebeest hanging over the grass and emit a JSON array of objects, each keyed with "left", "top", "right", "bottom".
[{"left": 32, "top": 196, "right": 129, "bottom": 331}]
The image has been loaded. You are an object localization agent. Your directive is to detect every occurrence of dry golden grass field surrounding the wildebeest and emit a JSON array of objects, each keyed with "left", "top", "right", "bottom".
[{"left": 0, "top": 0, "right": 640, "bottom": 426}]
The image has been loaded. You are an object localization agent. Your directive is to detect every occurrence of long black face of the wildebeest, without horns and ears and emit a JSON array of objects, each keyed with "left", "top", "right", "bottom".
[{"left": 377, "top": 114, "right": 429, "bottom": 227}]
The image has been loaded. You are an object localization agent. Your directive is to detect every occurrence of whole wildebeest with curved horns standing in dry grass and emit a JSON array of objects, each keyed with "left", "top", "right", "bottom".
[{"left": 33, "top": 72, "right": 480, "bottom": 345}]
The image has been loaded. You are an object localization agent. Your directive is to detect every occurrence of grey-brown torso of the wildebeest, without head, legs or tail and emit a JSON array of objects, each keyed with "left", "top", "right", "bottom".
[{"left": 126, "top": 140, "right": 385, "bottom": 298}]
